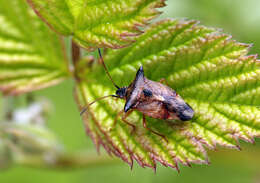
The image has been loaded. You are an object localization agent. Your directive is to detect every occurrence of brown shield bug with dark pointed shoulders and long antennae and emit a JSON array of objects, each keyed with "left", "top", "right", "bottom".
[{"left": 80, "top": 49, "right": 194, "bottom": 141}]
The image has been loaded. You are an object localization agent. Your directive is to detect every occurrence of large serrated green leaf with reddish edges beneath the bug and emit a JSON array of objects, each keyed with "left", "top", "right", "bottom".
[{"left": 76, "top": 20, "right": 260, "bottom": 168}]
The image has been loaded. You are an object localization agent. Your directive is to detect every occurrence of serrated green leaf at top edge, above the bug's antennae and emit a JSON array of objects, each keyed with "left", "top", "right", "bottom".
[{"left": 27, "top": 0, "right": 165, "bottom": 50}]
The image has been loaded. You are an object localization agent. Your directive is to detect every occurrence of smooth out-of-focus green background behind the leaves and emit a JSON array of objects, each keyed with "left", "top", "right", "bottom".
[{"left": 0, "top": 0, "right": 260, "bottom": 183}]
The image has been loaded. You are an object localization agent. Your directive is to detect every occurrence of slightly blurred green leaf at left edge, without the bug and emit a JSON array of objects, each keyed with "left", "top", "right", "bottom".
[{"left": 0, "top": 0, "right": 69, "bottom": 95}]
